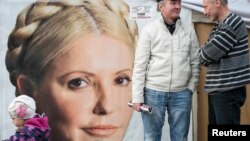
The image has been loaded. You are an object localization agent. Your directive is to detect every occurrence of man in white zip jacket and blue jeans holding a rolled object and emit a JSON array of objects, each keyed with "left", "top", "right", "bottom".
[{"left": 132, "top": 0, "right": 199, "bottom": 141}]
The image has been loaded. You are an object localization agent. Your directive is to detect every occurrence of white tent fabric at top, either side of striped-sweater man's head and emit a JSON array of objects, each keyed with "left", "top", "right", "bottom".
[{"left": 182, "top": 0, "right": 250, "bottom": 28}]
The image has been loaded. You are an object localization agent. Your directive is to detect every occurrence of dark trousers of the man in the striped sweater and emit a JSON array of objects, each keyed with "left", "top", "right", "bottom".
[{"left": 208, "top": 86, "right": 246, "bottom": 125}]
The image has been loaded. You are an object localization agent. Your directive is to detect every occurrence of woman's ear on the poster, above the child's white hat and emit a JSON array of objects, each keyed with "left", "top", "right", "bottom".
[{"left": 16, "top": 74, "right": 34, "bottom": 97}]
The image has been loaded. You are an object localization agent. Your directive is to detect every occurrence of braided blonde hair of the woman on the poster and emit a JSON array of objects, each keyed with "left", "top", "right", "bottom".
[{"left": 6, "top": 0, "right": 138, "bottom": 93}]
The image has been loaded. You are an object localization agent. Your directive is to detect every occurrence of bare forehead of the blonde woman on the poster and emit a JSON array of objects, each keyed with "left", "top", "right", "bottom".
[{"left": 48, "top": 36, "right": 133, "bottom": 69}]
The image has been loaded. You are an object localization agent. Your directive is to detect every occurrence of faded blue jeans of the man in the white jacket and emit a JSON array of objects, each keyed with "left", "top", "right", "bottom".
[{"left": 142, "top": 88, "right": 193, "bottom": 141}]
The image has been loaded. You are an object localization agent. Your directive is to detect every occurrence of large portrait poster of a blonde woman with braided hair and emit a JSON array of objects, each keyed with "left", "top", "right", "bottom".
[{"left": 0, "top": 0, "right": 192, "bottom": 141}]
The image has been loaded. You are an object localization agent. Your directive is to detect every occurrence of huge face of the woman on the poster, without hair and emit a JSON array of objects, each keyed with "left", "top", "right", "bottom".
[{"left": 35, "top": 35, "right": 133, "bottom": 141}]
